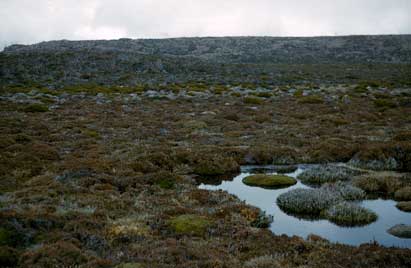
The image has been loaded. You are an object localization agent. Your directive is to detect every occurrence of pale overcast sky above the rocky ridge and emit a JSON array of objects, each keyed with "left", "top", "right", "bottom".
[{"left": 0, "top": 0, "right": 411, "bottom": 49}]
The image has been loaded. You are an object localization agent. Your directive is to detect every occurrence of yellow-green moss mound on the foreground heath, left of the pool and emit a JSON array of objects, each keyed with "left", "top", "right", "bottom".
[{"left": 170, "top": 214, "right": 211, "bottom": 236}]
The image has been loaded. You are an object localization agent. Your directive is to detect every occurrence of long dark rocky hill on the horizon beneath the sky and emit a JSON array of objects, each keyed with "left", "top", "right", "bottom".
[{"left": 0, "top": 35, "right": 411, "bottom": 86}]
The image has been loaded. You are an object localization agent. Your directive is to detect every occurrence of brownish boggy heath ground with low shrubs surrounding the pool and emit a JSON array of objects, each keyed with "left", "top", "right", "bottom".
[{"left": 0, "top": 82, "right": 411, "bottom": 267}]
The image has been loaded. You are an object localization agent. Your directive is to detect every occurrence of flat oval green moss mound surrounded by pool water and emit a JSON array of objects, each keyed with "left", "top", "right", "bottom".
[{"left": 243, "top": 174, "right": 297, "bottom": 188}]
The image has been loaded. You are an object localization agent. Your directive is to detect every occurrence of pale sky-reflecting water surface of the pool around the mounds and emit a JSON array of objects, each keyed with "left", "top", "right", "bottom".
[{"left": 199, "top": 165, "right": 411, "bottom": 248}]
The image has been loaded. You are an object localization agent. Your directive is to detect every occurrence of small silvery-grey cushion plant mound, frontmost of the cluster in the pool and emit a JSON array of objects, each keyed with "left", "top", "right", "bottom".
[{"left": 324, "top": 202, "right": 378, "bottom": 226}]
